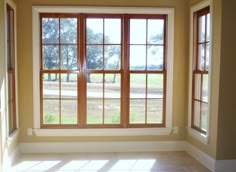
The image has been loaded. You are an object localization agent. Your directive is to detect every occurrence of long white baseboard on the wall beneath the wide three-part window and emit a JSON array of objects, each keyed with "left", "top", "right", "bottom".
[{"left": 20, "top": 141, "right": 185, "bottom": 153}]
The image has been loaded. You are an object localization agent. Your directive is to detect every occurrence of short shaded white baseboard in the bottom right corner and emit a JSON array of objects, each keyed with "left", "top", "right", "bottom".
[{"left": 215, "top": 159, "right": 236, "bottom": 172}]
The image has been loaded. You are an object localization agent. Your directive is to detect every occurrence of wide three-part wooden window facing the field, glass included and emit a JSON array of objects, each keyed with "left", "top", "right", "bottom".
[{"left": 40, "top": 14, "right": 167, "bottom": 128}]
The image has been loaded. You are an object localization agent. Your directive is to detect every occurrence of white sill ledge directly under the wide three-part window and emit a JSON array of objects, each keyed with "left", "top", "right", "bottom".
[{"left": 31, "top": 128, "right": 172, "bottom": 136}]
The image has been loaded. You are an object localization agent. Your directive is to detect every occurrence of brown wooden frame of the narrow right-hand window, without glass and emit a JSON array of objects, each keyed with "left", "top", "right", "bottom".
[{"left": 191, "top": 6, "right": 210, "bottom": 135}]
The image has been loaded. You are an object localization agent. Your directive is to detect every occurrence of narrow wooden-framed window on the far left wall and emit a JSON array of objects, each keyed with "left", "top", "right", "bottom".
[{"left": 6, "top": 4, "right": 17, "bottom": 134}]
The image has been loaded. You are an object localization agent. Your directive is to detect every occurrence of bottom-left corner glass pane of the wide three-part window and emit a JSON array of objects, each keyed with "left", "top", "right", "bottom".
[{"left": 43, "top": 100, "right": 60, "bottom": 124}]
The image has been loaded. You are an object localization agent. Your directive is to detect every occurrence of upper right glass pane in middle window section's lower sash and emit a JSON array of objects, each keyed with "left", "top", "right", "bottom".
[{"left": 105, "top": 74, "right": 121, "bottom": 98}]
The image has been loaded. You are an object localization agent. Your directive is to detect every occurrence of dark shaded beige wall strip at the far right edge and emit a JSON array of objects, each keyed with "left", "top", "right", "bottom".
[{"left": 217, "top": 0, "right": 236, "bottom": 159}]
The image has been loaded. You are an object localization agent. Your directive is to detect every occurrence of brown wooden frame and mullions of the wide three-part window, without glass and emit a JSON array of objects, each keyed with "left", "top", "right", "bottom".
[{"left": 40, "top": 13, "right": 167, "bottom": 128}]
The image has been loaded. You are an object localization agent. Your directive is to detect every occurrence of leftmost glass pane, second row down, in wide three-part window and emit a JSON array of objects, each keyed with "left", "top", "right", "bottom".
[{"left": 43, "top": 45, "right": 59, "bottom": 70}]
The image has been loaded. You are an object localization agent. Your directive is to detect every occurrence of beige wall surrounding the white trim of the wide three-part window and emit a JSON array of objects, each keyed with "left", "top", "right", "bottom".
[{"left": 17, "top": 0, "right": 189, "bottom": 142}]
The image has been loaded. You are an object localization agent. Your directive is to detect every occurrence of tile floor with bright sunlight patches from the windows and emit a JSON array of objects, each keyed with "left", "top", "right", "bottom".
[{"left": 11, "top": 152, "right": 210, "bottom": 172}]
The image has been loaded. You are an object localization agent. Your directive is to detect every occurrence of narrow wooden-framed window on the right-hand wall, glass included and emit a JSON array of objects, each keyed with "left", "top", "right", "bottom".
[{"left": 191, "top": 7, "right": 210, "bottom": 135}]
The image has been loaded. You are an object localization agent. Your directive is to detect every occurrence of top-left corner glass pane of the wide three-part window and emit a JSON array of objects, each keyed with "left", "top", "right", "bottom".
[{"left": 42, "top": 18, "right": 59, "bottom": 43}]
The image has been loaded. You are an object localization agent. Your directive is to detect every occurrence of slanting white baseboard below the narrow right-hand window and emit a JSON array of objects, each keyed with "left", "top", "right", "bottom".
[{"left": 185, "top": 142, "right": 216, "bottom": 172}]
